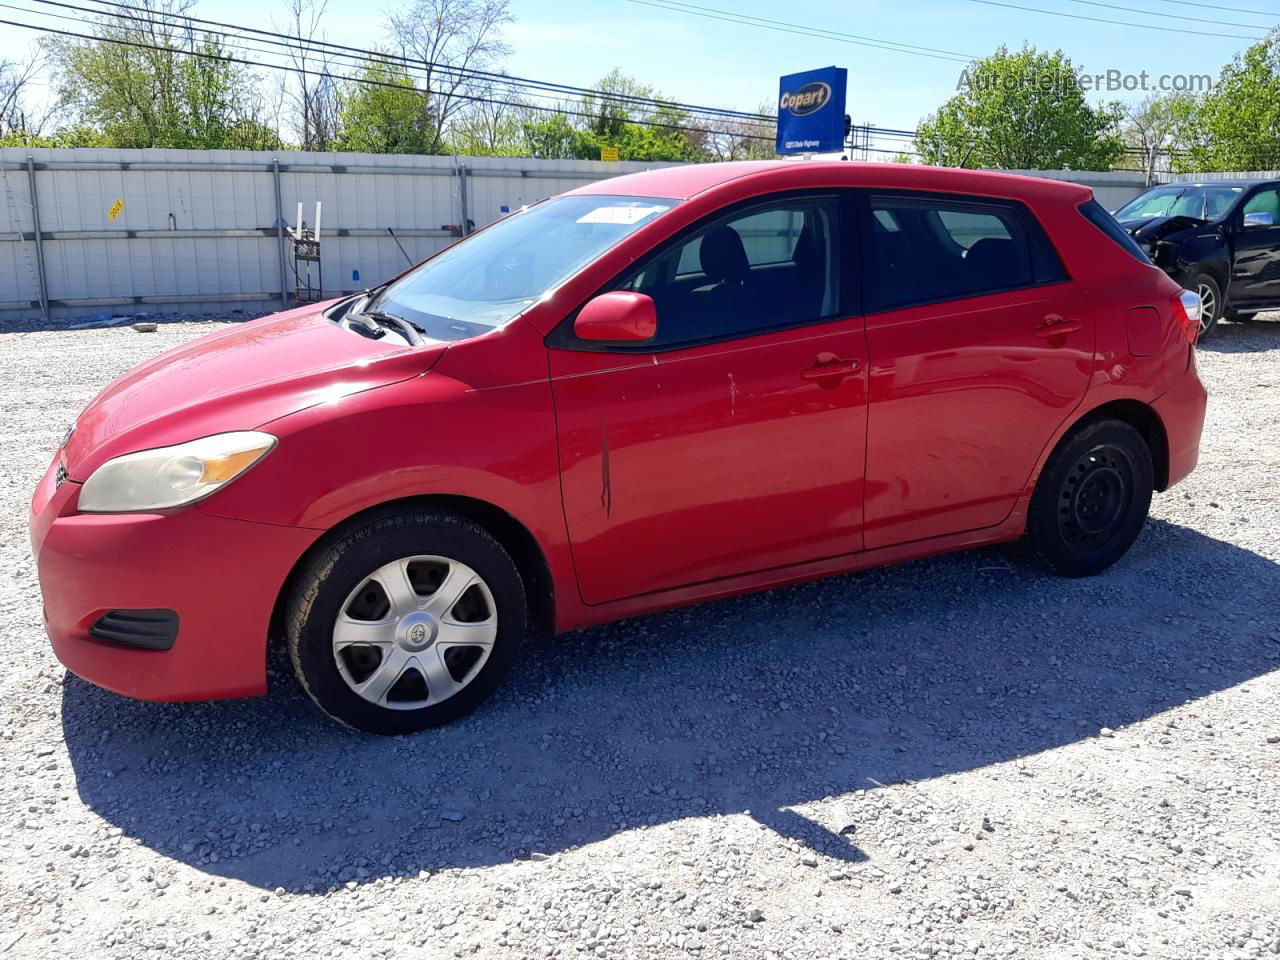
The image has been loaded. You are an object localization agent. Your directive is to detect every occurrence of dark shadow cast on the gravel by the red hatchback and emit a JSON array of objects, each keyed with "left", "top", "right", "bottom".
[{"left": 63, "top": 519, "right": 1280, "bottom": 891}]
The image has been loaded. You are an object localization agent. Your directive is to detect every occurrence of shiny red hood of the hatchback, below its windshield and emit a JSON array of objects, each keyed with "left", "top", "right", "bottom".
[{"left": 63, "top": 303, "right": 448, "bottom": 481}]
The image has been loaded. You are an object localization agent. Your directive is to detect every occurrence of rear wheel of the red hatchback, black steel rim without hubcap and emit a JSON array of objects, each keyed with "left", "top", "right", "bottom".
[{"left": 1027, "top": 420, "right": 1155, "bottom": 577}]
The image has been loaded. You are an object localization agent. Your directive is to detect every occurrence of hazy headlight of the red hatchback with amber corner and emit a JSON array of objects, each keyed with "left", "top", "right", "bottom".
[{"left": 78, "top": 430, "right": 275, "bottom": 513}]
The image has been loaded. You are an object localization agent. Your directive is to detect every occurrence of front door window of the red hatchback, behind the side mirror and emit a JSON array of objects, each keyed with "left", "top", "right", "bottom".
[{"left": 613, "top": 197, "right": 841, "bottom": 349}]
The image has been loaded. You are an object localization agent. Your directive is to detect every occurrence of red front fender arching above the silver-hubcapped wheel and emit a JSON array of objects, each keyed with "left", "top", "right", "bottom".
[{"left": 197, "top": 358, "right": 575, "bottom": 627}]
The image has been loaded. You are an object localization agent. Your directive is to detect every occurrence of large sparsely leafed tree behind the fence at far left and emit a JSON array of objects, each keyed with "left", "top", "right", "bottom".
[{"left": 47, "top": 0, "right": 280, "bottom": 150}]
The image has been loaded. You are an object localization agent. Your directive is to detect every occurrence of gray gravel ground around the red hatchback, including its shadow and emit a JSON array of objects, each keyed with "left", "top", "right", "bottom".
[{"left": 0, "top": 323, "right": 1280, "bottom": 960}]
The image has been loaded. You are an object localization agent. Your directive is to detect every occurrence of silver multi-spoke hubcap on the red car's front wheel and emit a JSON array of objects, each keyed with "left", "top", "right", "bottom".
[{"left": 333, "top": 556, "right": 498, "bottom": 710}]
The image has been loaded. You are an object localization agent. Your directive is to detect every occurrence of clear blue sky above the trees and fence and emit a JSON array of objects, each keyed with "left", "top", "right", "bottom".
[{"left": 0, "top": 0, "right": 1280, "bottom": 135}]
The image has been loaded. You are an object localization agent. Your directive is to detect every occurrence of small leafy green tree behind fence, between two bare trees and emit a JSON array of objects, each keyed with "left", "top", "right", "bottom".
[{"left": 337, "top": 60, "right": 438, "bottom": 154}]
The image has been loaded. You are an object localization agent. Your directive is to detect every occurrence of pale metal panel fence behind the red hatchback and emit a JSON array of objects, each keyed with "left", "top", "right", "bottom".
[{"left": 0, "top": 148, "right": 1162, "bottom": 324}]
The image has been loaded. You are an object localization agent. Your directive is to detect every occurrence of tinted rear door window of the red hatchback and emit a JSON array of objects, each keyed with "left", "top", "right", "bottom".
[{"left": 867, "top": 195, "right": 1066, "bottom": 310}]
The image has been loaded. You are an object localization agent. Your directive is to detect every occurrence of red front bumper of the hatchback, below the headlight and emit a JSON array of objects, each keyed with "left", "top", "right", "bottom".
[{"left": 31, "top": 460, "right": 320, "bottom": 700}]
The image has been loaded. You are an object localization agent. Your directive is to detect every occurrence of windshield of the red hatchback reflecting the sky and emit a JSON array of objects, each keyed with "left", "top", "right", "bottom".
[{"left": 358, "top": 196, "right": 676, "bottom": 340}]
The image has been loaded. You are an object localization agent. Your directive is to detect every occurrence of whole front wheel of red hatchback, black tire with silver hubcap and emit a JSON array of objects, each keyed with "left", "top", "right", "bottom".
[{"left": 285, "top": 509, "right": 527, "bottom": 735}]
